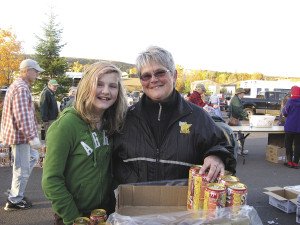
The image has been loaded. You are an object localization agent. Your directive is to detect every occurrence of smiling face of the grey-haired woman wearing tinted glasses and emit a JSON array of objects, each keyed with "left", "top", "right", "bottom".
[{"left": 140, "top": 63, "right": 177, "bottom": 102}]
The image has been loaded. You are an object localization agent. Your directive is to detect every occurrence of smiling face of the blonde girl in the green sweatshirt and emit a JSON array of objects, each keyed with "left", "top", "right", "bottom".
[{"left": 93, "top": 73, "right": 119, "bottom": 112}]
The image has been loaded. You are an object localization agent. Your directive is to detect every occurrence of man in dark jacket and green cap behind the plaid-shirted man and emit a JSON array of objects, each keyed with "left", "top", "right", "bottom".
[{"left": 40, "top": 79, "right": 58, "bottom": 133}]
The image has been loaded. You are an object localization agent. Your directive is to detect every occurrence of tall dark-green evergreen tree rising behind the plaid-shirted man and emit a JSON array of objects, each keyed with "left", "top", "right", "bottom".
[{"left": 34, "top": 12, "right": 70, "bottom": 94}]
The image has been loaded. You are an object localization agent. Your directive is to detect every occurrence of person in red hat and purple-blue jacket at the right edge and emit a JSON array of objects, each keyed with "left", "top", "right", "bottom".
[{"left": 282, "top": 86, "right": 300, "bottom": 169}]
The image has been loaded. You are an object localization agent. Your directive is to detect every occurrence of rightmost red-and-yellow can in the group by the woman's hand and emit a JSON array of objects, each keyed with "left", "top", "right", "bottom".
[{"left": 226, "top": 183, "right": 248, "bottom": 207}]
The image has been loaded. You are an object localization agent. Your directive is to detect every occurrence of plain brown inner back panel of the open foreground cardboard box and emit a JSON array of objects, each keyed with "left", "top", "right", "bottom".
[{"left": 118, "top": 185, "right": 187, "bottom": 207}]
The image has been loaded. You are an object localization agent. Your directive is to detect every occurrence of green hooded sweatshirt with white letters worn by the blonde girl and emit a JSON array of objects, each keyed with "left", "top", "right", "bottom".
[{"left": 42, "top": 107, "right": 115, "bottom": 224}]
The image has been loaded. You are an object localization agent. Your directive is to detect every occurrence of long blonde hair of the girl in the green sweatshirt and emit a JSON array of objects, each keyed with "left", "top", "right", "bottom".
[{"left": 74, "top": 62, "right": 127, "bottom": 135}]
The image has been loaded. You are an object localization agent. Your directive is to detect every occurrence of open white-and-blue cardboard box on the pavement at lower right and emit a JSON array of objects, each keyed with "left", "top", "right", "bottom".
[{"left": 264, "top": 187, "right": 300, "bottom": 213}]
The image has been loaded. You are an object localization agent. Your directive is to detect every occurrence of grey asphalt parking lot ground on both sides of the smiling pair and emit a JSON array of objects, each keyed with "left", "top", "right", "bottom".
[{"left": 0, "top": 131, "right": 300, "bottom": 225}]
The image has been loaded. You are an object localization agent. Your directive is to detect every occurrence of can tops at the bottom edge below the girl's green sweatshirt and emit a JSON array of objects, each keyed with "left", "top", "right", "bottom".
[{"left": 73, "top": 209, "right": 107, "bottom": 225}]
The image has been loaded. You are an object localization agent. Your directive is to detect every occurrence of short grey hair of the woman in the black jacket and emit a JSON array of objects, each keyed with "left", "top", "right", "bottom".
[{"left": 136, "top": 46, "right": 176, "bottom": 76}]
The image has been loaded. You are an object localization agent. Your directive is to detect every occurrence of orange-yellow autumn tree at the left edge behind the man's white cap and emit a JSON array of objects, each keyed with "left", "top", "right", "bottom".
[{"left": 0, "top": 29, "right": 23, "bottom": 86}]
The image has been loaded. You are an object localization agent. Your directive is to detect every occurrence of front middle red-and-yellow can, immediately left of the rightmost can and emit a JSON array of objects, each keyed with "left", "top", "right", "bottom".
[{"left": 203, "top": 183, "right": 226, "bottom": 210}]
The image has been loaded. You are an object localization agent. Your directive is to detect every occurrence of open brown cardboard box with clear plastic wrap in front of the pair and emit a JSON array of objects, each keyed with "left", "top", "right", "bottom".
[{"left": 113, "top": 184, "right": 254, "bottom": 225}]
